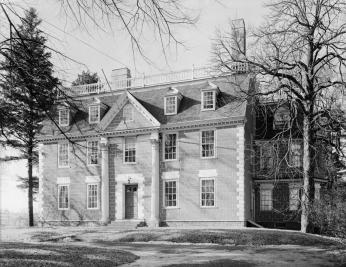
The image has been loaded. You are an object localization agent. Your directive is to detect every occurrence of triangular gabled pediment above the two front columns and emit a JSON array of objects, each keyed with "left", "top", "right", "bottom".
[{"left": 100, "top": 91, "right": 160, "bottom": 130}]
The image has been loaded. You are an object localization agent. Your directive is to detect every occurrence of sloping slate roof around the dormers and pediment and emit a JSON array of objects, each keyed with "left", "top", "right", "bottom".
[{"left": 41, "top": 74, "right": 251, "bottom": 139}]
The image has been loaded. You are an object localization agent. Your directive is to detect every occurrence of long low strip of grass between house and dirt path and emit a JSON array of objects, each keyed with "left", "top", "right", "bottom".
[{"left": 104, "top": 229, "right": 342, "bottom": 246}]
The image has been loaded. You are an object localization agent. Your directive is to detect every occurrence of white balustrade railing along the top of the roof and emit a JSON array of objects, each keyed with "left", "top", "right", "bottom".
[{"left": 61, "top": 63, "right": 248, "bottom": 96}]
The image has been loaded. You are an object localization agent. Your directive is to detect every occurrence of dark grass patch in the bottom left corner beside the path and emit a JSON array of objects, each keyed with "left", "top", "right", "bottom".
[{"left": 0, "top": 242, "right": 139, "bottom": 267}]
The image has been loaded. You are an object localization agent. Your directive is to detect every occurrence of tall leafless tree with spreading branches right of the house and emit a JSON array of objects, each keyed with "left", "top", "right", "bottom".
[{"left": 214, "top": 0, "right": 346, "bottom": 232}]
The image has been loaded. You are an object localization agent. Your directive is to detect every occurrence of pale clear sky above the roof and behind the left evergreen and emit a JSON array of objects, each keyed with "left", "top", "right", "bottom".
[{"left": 0, "top": 0, "right": 267, "bottom": 214}]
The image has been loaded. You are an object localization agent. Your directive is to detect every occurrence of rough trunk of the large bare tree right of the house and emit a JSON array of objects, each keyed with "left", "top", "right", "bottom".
[{"left": 300, "top": 114, "right": 314, "bottom": 233}]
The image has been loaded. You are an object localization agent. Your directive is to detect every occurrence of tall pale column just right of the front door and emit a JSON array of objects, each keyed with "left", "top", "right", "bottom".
[{"left": 150, "top": 132, "right": 160, "bottom": 227}]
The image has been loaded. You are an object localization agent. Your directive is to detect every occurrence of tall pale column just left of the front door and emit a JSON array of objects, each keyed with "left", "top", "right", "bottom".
[{"left": 100, "top": 137, "right": 109, "bottom": 224}]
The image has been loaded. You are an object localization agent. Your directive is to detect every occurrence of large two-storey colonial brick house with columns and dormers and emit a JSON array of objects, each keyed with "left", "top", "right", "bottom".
[{"left": 39, "top": 65, "right": 255, "bottom": 227}]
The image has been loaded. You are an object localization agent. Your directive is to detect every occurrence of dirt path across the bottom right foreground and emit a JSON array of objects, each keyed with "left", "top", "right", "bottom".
[{"left": 90, "top": 243, "right": 346, "bottom": 267}]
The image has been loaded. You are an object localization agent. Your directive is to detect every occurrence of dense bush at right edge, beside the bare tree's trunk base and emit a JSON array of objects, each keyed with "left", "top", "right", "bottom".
[{"left": 311, "top": 185, "right": 346, "bottom": 238}]
